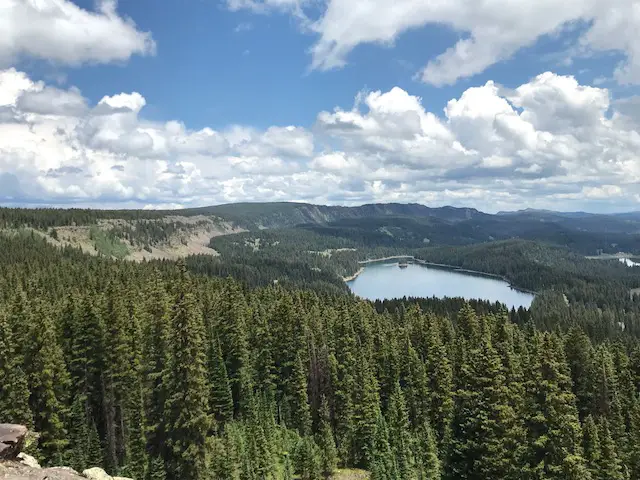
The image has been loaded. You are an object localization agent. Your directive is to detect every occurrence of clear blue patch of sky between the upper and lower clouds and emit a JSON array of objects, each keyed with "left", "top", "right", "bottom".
[{"left": 24, "top": 0, "right": 632, "bottom": 129}]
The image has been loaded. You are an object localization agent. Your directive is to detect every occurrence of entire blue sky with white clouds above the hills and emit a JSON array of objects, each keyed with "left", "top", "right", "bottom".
[{"left": 0, "top": 0, "right": 640, "bottom": 213}]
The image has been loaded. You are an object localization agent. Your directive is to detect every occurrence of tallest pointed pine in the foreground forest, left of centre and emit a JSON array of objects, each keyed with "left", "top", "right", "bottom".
[{"left": 165, "top": 267, "right": 211, "bottom": 480}]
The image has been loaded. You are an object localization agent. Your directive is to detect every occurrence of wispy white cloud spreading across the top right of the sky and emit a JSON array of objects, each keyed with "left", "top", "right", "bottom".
[{"left": 227, "top": 0, "right": 640, "bottom": 85}]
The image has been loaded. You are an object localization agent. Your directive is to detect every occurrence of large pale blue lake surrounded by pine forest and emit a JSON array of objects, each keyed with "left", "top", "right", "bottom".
[{"left": 347, "top": 262, "right": 533, "bottom": 309}]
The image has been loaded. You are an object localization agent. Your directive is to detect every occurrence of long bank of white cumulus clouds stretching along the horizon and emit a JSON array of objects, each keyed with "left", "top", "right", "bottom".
[{"left": 0, "top": 69, "right": 640, "bottom": 211}]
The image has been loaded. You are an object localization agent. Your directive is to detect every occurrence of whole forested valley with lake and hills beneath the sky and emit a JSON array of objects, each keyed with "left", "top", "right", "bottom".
[{"left": 0, "top": 204, "right": 640, "bottom": 480}]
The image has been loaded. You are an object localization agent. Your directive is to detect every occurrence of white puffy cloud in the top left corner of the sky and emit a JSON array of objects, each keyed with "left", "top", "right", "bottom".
[{"left": 0, "top": 0, "right": 155, "bottom": 67}]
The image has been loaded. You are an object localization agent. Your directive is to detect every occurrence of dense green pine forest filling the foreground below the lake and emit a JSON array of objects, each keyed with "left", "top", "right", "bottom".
[{"left": 0, "top": 222, "right": 640, "bottom": 480}]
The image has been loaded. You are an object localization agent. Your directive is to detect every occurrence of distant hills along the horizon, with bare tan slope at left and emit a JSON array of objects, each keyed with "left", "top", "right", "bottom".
[{"left": 0, "top": 203, "right": 640, "bottom": 260}]
